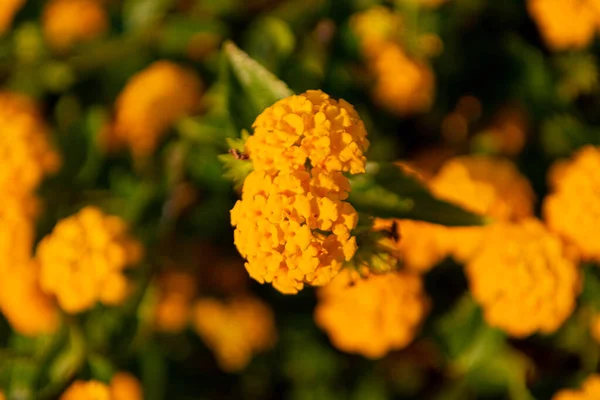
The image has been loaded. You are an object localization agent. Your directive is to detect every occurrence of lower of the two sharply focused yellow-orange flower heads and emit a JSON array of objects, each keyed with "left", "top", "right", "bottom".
[{"left": 231, "top": 168, "right": 358, "bottom": 293}]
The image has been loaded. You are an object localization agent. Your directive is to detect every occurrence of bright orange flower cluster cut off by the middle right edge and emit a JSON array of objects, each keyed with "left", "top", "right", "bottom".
[{"left": 544, "top": 146, "right": 600, "bottom": 261}]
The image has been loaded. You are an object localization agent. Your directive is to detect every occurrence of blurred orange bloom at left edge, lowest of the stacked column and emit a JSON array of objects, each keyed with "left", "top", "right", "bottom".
[{"left": 0, "top": 260, "right": 59, "bottom": 336}]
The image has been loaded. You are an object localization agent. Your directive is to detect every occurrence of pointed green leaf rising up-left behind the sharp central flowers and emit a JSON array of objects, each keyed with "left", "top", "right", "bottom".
[{"left": 223, "top": 42, "right": 294, "bottom": 122}]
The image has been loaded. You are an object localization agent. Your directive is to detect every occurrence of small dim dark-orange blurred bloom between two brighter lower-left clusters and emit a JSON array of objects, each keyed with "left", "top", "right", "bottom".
[{"left": 154, "top": 270, "right": 197, "bottom": 333}]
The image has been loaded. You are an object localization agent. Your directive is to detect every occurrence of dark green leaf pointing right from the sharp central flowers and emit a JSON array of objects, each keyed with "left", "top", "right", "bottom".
[{"left": 350, "top": 164, "right": 486, "bottom": 226}]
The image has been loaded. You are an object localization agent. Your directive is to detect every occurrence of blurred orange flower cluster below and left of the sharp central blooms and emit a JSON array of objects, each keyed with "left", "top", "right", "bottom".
[{"left": 193, "top": 296, "right": 277, "bottom": 372}]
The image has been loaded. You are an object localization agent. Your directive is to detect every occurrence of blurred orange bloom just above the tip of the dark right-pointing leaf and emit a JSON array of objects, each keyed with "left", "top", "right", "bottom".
[{"left": 430, "top": 156, "right": 535, "bottom": 221}]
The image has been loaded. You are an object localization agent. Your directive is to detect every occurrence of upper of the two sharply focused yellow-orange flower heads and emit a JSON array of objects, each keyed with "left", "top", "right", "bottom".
[{"left": 246, "top": 90, "right": 369, "bottom": 174}]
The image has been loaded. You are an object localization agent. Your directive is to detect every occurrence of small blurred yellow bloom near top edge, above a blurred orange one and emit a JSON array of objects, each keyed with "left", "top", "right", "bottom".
[{"left": 350, "top": 6, "right": 403, "bottom": 57}]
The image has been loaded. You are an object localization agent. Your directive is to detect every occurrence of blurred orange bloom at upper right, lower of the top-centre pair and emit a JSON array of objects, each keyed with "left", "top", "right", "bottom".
[{"left": 369, "top": 42, "right": 435, "bottom": 115}]
